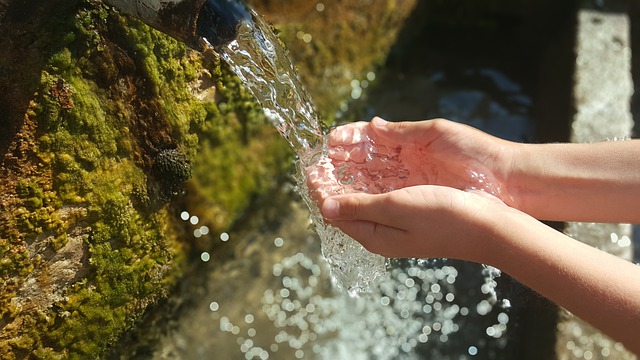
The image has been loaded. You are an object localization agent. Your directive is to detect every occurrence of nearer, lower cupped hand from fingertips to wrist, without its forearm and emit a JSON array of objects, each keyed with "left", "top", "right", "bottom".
[{"left": 321, "top": 185, "right": 518, "bottom": 262}]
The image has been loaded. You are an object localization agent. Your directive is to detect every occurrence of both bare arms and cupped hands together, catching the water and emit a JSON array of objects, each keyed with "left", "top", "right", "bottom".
[{"left": 310, "top": 118, "right": 640, "bottom": 354}]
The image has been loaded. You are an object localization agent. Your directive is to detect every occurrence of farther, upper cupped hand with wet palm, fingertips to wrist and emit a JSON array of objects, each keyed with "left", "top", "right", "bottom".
[{"left": 329, "top": 117, "right": 515, "bottom": 204}]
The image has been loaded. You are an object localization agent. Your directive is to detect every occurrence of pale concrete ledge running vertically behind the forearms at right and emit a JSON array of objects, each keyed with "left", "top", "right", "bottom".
[{"left": 556, "top": 5, "right": 636, "bottom": 360}]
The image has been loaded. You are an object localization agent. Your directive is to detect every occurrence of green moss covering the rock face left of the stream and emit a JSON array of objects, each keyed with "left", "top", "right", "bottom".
[{"left": 0, "top": 0, "right": 292, "bottom": 359}]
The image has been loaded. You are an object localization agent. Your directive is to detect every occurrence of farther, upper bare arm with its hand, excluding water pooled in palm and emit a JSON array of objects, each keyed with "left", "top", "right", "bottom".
[{"left": 356, "top": 118, "right": 640, "bottom": 223}]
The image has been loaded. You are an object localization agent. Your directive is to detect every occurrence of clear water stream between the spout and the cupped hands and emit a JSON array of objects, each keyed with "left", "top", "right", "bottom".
[{"left": 202, "top": 11, "right": 324, "bottom": 164}]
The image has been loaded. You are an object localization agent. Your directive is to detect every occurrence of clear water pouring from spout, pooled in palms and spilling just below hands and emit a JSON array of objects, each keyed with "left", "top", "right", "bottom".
[{"left": 202, "top": 3, "right": 508, "bottom": 294}]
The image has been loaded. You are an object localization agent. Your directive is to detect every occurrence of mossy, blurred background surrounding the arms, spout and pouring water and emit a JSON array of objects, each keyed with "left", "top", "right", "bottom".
[{"left": 0, "top": 0, "right": 640, "bottom": 359}]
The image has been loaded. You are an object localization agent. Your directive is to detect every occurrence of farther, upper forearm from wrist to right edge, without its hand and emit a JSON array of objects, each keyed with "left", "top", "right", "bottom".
[{"left": 507, "top": 140, "right": 640, "bottom": 223}]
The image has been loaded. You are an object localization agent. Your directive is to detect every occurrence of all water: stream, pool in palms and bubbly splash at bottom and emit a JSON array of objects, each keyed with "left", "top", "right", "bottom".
[{"left": 174, "top": 1, "right": 524, "bottom": 359}]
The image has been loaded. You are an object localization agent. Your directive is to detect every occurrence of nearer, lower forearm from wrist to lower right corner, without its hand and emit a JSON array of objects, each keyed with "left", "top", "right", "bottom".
[{"left": 488, "top": 214, "right": 640, "bottom": 354}]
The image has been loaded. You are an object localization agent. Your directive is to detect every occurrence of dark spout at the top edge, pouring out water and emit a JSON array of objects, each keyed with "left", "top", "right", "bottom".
[{"left": 104, "top": 0, "right": 251, "bottom": 49}]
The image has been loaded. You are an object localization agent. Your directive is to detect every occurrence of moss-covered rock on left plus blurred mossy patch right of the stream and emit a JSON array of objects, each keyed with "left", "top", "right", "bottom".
[{"left": 0, "top": 0, "right": 412, "bottom": 359}]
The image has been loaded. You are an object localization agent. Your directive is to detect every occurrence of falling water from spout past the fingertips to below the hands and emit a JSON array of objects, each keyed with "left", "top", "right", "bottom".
[{"left": 200, "top": 2, "right": 391, "bottom": 293}]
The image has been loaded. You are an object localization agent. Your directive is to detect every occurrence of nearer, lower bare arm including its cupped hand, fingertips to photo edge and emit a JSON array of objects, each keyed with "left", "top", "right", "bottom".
[{"left": 322, "top": 185, "right": 640, "bottom": 354}]
